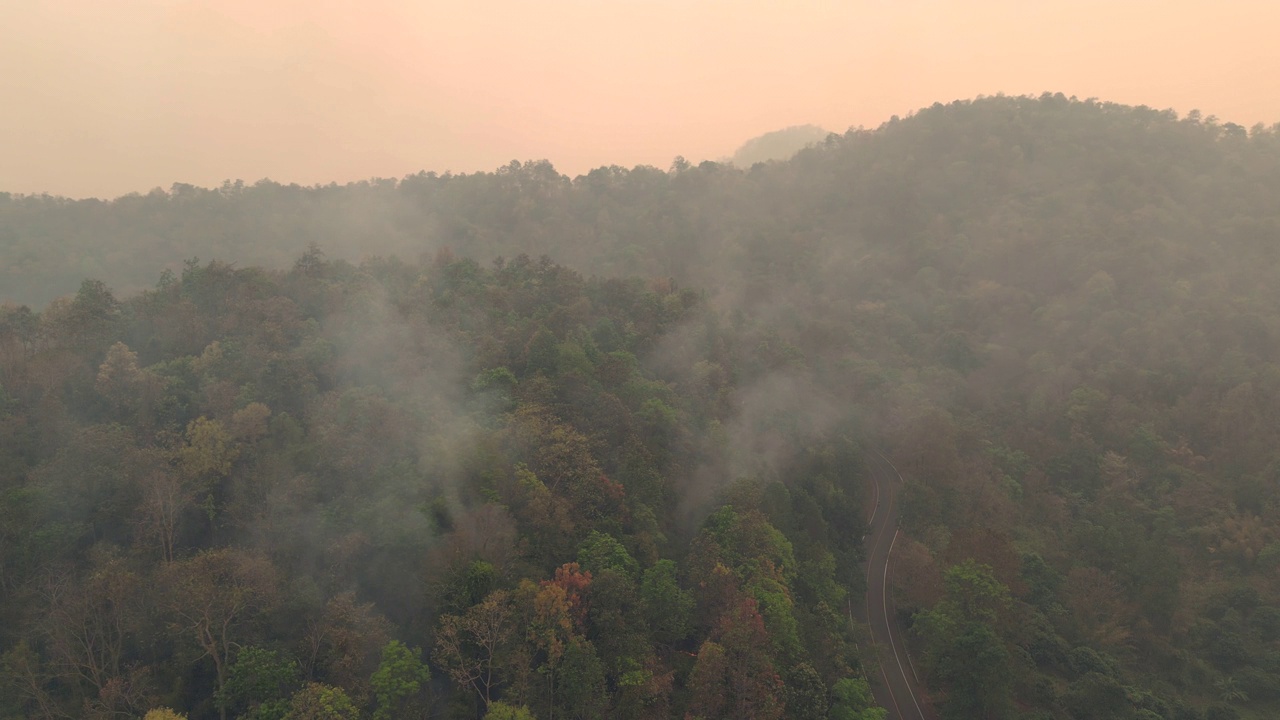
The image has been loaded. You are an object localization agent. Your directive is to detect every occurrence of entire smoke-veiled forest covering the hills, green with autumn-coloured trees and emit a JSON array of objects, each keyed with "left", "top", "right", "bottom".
[{"left": 0, "top": 95, "right": 1280, "bottom": 720}]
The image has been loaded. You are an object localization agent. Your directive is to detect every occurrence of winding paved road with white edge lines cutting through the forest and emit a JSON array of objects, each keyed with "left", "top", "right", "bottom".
[{"left": 865, "top": 451, "right": 937, "bottom": 720}]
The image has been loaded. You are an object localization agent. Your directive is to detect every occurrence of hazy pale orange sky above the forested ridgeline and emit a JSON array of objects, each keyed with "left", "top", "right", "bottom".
[{"left": 0, "top": 0, "right": 1280, "bottom": 196}]
